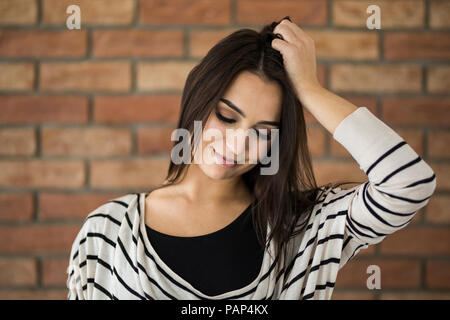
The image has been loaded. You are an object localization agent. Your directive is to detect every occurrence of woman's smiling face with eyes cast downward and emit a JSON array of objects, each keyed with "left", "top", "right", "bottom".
[{"left": 197, "top": 71, "right": 282, "bottom": 179}]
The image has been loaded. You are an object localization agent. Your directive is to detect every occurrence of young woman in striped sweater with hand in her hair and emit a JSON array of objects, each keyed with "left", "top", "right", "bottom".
[{"left": 68, "top": 17, "right": 436, "bottom": 299}]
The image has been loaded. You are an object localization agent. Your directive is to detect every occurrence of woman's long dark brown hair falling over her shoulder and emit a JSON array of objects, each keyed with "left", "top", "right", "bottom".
[{"left": 151, "top": 17, "right": 360, "bottom": 270}]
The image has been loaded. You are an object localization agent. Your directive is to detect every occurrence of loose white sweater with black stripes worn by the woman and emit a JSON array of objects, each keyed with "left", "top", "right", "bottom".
[{"left": 67, "top": 107, "right": 436, "bottom": 300}]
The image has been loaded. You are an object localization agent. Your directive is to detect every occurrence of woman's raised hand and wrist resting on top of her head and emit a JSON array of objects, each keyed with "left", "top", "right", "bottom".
[{"left": 272, "top": 19, "right": 322, "bottom": 101}]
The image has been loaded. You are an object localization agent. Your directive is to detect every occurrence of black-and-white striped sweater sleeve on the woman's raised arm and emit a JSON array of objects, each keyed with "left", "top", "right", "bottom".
[{"left": 332, "top": 107, "right": 436, "bottom": 268}]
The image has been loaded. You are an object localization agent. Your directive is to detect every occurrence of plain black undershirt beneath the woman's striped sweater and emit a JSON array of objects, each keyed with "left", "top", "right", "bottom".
[{"left": 146, "top": 201, "right": 264, "bottom": 296}]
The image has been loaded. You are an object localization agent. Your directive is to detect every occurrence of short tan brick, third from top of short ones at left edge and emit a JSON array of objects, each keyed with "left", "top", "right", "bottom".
[{"left": 0, "top": 128, "right": 36, "bottom": 156}]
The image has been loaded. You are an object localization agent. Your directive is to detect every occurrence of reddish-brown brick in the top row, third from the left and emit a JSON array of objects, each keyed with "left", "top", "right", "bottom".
[{"left": 139, "top": 0, "right": 231, "bottom": 25}]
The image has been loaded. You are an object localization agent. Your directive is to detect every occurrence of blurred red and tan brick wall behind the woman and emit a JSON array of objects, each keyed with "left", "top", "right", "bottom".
[{"left": 0, "top": 0, "right": 450, "bottom": 299}]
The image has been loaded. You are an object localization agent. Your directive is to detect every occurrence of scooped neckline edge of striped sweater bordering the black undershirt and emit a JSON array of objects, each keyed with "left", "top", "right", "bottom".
[{"left": 137, "top": 192, "right": 274, "bottom": 299}]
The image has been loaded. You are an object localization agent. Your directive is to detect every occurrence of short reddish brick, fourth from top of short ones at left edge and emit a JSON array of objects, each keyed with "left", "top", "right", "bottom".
[{"left": 0, "top": 193, "right": 34, "bottom": 222}]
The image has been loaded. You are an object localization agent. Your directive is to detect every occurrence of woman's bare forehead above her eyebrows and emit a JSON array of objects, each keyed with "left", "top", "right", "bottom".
[{"left": 224, "top": 71, "right": 282, "bottom": 121}]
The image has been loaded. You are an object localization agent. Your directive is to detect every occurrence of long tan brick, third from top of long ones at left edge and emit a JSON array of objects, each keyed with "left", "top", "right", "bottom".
[{"left": 0, "top": 160, "right": 85, "bottom": 187}]
